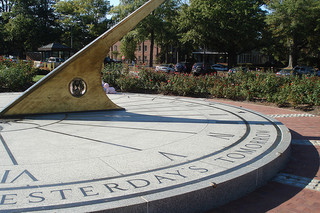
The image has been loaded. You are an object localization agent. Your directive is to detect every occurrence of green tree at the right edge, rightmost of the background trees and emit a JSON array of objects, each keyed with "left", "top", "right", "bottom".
[{"left": 266, "top": 0, "right": 320, "bottom": 67}]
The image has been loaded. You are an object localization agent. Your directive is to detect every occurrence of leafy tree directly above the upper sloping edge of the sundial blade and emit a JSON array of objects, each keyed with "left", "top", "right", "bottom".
[{"left": 56, "top": 0, "right": 111, "bottom": 49}]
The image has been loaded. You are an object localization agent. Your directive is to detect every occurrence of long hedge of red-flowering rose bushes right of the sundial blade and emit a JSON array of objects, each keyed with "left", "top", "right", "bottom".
[{"left": 103, "top": 65, "right": 320, "bottom": 106}]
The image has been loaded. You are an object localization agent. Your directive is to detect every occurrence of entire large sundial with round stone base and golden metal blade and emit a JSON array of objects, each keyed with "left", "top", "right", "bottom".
[{"left": 0, "top": 1, "right": 291, "bottom": 213}]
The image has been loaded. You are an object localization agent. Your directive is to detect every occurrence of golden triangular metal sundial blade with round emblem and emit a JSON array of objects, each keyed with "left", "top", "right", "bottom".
[{"left": 0, "top": 0, "right": 164, "bottom": 117}]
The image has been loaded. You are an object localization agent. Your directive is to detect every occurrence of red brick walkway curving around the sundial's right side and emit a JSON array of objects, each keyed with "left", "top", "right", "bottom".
[{"left": 207, "top": 99, "right": 320, "bottom": 213}]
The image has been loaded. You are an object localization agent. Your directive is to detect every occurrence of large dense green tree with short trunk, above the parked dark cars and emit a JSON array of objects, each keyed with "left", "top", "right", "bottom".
[{"left": 179, "top": 0, "right": 265, "bottom": 66}]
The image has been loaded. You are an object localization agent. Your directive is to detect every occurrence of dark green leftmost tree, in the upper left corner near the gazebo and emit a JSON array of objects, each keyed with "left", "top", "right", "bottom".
[{"left": 2, "top": 0, "right": 57, "bottom": 56}]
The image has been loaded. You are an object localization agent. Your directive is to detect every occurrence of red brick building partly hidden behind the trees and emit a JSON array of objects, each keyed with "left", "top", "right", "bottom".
[{"left": 109, "top": 40, "right": 160, "bottom": 64}]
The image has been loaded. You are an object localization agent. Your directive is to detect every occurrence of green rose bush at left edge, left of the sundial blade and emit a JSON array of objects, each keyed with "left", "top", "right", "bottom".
[{"left": 0, "top": 60, "right": 35, "bottom": 92}]
